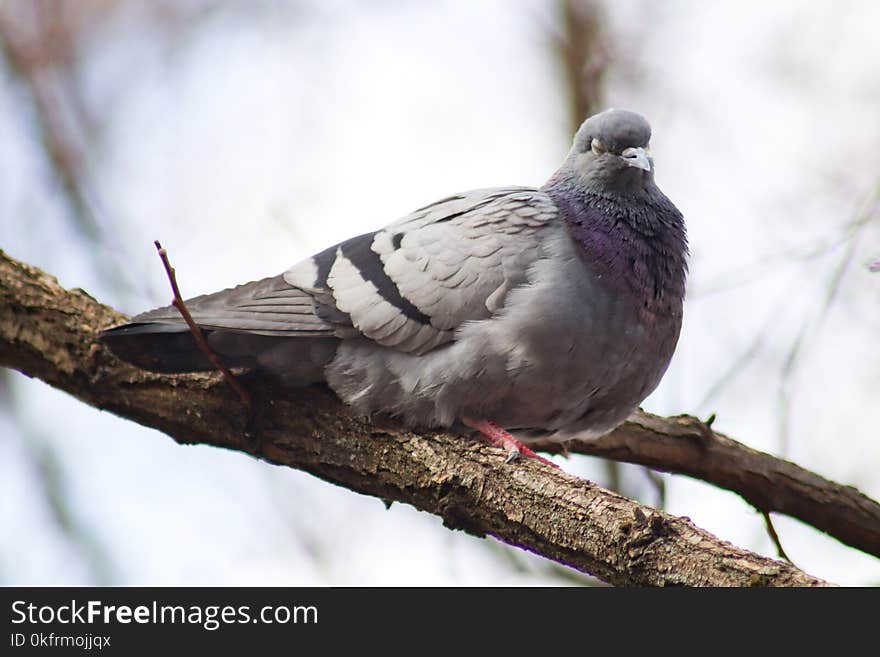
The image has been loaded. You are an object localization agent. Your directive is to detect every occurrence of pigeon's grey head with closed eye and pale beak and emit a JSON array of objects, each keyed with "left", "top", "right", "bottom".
[{"left": 566, "top": 109, "right": 654, "bottom": 192}]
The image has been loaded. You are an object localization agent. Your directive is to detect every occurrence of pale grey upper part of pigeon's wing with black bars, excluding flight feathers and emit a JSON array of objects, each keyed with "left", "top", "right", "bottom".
[{"left": 284, "top": 187, "right": 558, "bottom": 354}]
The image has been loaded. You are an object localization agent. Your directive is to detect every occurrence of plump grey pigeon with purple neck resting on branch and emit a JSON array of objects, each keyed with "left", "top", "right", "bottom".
[{"left": 101, "top": 109, "right": 688, "bottom": 459}]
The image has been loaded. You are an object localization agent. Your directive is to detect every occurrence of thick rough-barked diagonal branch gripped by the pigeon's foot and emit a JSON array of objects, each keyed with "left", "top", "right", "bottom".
[{"left": 0, "top": 251, "right": 844, "bottom": 586}]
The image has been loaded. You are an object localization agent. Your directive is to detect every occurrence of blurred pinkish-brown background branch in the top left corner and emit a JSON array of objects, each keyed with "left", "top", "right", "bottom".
[{"left": 0, "top": 0, "right": 230, "bottom": 293}]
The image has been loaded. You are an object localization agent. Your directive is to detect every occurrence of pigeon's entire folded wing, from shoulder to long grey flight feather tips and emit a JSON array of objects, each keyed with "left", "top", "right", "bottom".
[{"left": 128, "top": 187, "right": 557, "bottom": 354}]
